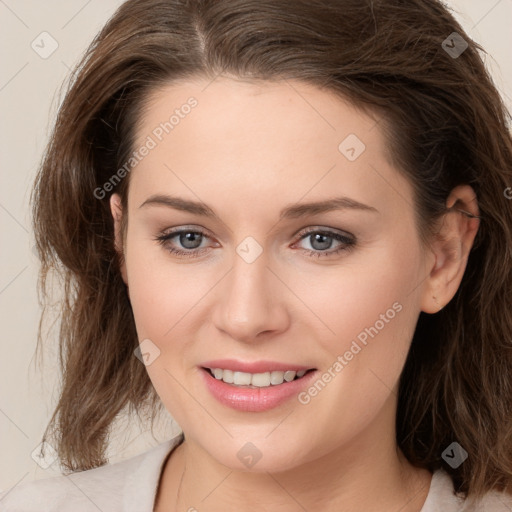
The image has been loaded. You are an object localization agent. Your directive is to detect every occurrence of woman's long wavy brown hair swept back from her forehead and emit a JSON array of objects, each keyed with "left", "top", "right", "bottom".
[{"left": 32, "top": 0, "right": 512, "bottom": 497}]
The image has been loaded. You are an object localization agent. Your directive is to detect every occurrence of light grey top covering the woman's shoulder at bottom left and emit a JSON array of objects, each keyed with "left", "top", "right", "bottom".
[{"left": 0, "top": 435, "right": 181, "bottom": 512}]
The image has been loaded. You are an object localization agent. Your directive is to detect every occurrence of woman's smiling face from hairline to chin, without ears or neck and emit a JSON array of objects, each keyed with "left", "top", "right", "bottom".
[{"left": 112, "top": 78, "right": 435, "bottom": 471}]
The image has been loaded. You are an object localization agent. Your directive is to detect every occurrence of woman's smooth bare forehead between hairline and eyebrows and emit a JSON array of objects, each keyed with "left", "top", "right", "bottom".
[{"left": 129, "top": 77, "right": 411, "bottom": 221}]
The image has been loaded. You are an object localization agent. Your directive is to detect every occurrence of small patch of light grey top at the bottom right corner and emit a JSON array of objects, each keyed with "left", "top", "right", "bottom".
[{"left": 420, "top": 469, "right": 512, "bottom": 512}]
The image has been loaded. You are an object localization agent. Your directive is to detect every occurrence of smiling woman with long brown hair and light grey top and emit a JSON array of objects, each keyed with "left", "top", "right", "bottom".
[{"left": 0, "top": 0, "right": 512, "bottom": 512}]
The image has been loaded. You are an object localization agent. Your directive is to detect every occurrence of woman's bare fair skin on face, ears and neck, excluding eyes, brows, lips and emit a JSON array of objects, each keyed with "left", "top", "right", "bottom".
[{"left": 111, "top": 77, "right": 479, "bottom": 512}]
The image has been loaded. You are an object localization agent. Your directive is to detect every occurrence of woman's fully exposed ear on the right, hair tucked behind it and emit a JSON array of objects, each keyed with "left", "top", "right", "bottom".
[{"left": 421, "top": 185, "right": 480, "bottom": 313}]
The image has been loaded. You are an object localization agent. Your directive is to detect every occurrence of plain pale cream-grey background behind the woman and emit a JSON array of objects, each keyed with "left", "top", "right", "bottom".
[{"left": 0, "top": 0, "right": 512, "bottom": 491}]
